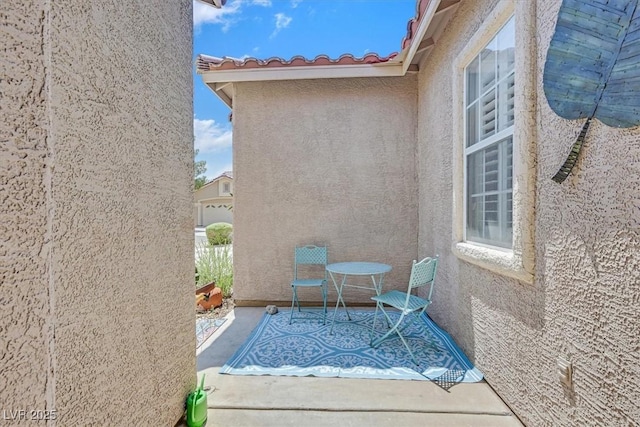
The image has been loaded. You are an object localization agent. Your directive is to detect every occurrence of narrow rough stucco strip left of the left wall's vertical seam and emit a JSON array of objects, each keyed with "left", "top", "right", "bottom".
[{"left": 0, "top": 2, "right": 53, "bottom": 410}]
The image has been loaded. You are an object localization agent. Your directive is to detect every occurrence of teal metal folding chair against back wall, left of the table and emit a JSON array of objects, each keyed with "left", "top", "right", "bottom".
[{"left": 289, "top": 245, "right": 327, "bottom": 324}]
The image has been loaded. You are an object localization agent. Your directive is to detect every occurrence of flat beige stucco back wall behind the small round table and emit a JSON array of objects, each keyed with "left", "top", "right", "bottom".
[{"left": 233, "top": 75, "right": 417, "bottom": 302}]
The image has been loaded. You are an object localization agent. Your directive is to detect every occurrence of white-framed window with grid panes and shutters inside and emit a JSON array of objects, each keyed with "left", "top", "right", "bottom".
[{"left": 464, "top": 17, "right": 515, "bottom": 249}]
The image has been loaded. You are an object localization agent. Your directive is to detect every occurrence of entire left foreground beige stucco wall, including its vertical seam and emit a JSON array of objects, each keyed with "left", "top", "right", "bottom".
[{"left": 0, "top": 0, "right": 195, "bottom": 425}]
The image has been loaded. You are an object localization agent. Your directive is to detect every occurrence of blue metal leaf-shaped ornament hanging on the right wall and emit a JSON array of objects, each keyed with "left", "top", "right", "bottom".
[{"left": 543, "top": 0, "right": 640, "bottom": 183}]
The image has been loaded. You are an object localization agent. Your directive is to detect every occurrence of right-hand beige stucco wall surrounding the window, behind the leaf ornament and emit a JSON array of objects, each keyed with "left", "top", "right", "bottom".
[{"left": 418, "top": 0, "right": 640, "bottom": 426}]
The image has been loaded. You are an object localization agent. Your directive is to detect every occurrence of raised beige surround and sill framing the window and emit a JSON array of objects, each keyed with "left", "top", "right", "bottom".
[{"left": 452, "top": 0, "right": 537, "bottom": 283}]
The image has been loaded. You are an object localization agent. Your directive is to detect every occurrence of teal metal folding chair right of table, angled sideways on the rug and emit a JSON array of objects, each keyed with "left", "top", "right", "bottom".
[{"left": 371, "top": 255, "right": 438, "bottom": 365}]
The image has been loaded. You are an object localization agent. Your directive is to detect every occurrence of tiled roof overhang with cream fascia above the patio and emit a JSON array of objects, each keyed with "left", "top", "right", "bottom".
[{"left": 196, "top": 0, "right": 460, "bottom": 107}]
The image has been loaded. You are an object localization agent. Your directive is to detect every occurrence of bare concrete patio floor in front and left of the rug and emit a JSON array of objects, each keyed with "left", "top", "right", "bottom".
[{"left": 188, "top": 307, "right": 522, "bottom": 427}]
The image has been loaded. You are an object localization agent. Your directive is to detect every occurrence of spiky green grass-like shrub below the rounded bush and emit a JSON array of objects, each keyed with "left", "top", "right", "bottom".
[{"left": 196, "top": 242, "right": 233, "bottom": 298}]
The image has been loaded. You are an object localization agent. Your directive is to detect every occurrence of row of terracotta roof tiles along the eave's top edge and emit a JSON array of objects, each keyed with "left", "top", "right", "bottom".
[{"left": 196, "top": 0, "right": 431, "bottom": 71}]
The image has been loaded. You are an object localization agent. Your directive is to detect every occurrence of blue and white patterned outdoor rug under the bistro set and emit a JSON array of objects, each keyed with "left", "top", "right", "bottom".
[{"left": 220, "top": 310, "right": 483, "bottom": 384}]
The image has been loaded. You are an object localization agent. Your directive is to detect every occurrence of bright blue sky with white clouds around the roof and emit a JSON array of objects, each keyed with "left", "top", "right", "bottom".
[{"left": 193, "top": 0, "right": 416, "bottom": 179}]
